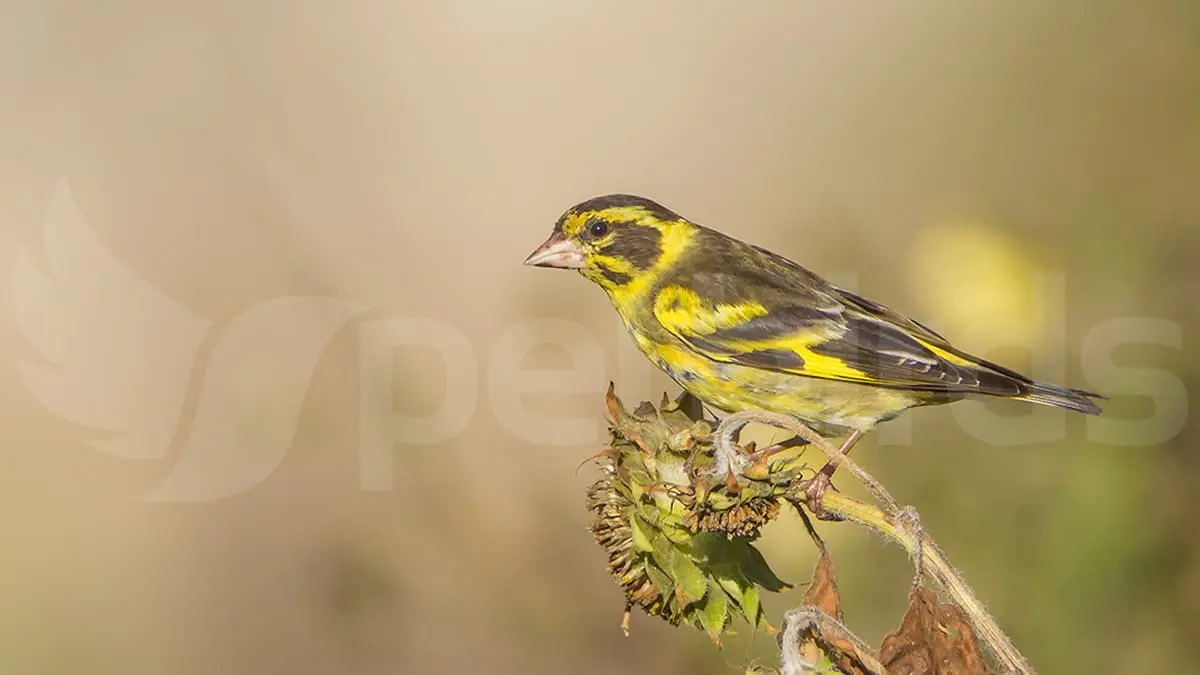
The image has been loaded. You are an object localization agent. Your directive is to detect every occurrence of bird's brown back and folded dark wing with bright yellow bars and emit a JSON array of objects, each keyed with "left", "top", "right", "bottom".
[{"left": 654, "top": 235, "right": 1028, "bottom": 396}]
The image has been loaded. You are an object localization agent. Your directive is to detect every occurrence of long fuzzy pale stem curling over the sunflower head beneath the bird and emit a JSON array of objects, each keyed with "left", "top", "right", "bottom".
[{"left": 714, "top": 411, "right": 1033, "bottom": 673}]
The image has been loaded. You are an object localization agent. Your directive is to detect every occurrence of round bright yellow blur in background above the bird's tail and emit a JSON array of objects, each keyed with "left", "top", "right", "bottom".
[{"left": 907, "top": 217, "right": 1045, "bottom": 340}]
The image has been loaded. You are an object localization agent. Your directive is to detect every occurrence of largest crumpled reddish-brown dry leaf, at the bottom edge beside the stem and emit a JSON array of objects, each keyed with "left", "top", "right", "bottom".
[{"left": 880, "top": 587, "right": 989, "bottom": 675}]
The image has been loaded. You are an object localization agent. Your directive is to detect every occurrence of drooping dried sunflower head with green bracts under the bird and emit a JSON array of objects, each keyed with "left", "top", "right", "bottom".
[{"left": 587, "top": 387, "right": 797, "bottom": 643}]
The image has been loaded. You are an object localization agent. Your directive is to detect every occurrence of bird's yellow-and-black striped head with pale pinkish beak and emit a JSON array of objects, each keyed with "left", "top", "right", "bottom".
[{"left": 524, "top": 195, "right": 696, "bottom": 293}]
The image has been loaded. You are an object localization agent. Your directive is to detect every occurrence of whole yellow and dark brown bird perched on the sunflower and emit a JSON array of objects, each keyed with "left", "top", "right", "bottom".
[{"left": 526, "top": 195, "right": 1104, "bottom": 510}]
